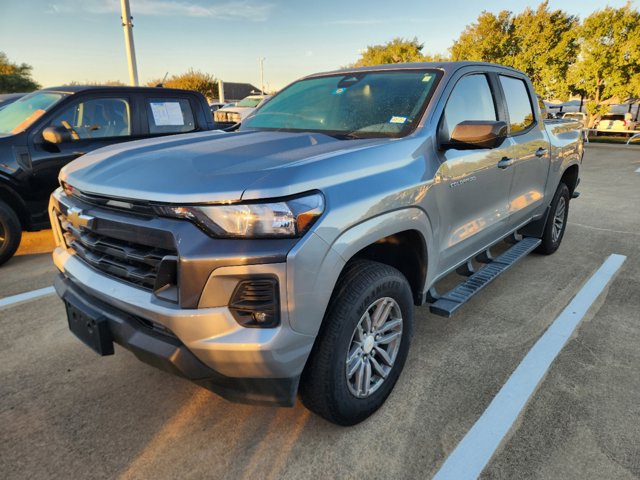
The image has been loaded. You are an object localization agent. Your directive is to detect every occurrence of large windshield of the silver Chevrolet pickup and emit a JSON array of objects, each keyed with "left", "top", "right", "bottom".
[{"left": 241, "top": 69, "right": 440, "bottom": 139}]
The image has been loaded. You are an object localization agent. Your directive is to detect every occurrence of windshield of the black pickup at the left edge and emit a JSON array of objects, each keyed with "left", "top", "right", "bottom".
[{"left": 0, "top": 92, "right": 67, "bottom": 135}]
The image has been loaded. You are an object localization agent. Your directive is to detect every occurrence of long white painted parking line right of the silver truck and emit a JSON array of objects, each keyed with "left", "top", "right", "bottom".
[{"left": 433, "top": 254, "right": 627, "bottom": 480}]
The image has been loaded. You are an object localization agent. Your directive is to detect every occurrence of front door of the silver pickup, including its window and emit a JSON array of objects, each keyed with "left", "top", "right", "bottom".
[{"left": 434, "top": 73, "right": 513, "bottom": 271}]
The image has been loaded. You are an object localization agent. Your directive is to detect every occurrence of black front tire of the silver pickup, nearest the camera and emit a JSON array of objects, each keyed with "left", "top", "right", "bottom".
[{"left": 300, "top": 260, "right": 413, "bottom": 425}]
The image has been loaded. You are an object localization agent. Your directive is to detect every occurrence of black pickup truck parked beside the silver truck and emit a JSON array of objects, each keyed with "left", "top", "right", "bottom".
[{"left": 0, "top": 86, "right": 214, "bottom": 265}]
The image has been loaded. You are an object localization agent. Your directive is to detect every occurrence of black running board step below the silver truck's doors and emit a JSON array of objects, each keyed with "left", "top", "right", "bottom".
[{"left": 429, "top": 237, "right": 542, "bottom": 317}]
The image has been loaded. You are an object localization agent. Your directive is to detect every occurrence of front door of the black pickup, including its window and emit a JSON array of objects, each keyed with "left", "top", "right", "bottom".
[{"left": 30, "top": 96, "right": 135, "bottom": 204}]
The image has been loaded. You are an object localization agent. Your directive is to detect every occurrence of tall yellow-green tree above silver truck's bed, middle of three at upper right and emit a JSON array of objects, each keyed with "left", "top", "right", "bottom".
[{"left": 508, "top": 1, "right": 578, "bottom": 99}]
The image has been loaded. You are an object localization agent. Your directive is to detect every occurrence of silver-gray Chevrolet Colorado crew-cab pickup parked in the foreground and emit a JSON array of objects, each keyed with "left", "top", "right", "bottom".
[{"left": 49, "top": 62, "right": 583, "bottom": 425}]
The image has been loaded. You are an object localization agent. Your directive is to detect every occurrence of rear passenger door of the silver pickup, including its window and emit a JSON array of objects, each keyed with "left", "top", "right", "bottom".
[{"left": 498, "top": 75, "right": 550, "bottom": 229}]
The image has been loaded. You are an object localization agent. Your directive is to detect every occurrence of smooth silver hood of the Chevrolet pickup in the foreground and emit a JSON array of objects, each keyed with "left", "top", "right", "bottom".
[{"left": 60, "top": 131, "right": 389, "bottom": 204}]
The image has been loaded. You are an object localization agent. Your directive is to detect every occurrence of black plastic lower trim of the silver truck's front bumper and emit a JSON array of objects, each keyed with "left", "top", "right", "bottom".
[{"left": 54, "top": 273, "right": 300, "bottom": 407}]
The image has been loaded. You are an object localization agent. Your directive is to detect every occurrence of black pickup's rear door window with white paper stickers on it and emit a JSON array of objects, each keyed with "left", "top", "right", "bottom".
[{"left": 147, "top": 98, "right": 196, "bottom": 134}]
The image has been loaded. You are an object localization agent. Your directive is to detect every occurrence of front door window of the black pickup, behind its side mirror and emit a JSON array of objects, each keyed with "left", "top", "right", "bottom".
[{"left": 49, "top": 98, "right": 131, "bottom": 140}]
